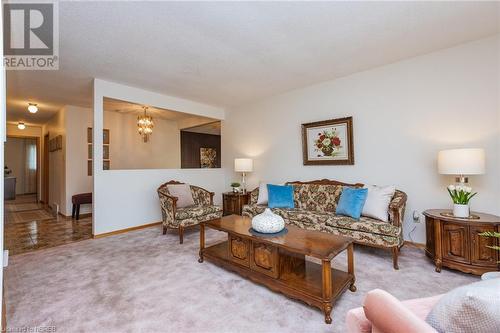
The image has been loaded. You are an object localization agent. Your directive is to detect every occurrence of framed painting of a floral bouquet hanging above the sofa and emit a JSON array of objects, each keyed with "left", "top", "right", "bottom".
[{"left": 302, "top": 117, "right": 354, "bottom": 165}]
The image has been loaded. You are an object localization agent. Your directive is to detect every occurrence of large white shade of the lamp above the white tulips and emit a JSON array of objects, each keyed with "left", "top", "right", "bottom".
[{"left": 438, "top": 148, "right": 485, "bottom": 175}]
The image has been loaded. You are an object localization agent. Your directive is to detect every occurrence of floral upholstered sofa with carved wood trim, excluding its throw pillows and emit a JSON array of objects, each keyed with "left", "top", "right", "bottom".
[{"left": 242, "top": 179, "right": 406, "bottom": 269}]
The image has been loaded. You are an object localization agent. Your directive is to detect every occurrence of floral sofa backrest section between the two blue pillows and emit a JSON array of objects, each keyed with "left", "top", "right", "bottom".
[{"left": 292, "top": 183, "right": 342, "bottom": 212}]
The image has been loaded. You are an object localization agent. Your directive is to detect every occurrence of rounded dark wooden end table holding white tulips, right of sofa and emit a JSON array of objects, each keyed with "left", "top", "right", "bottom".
[{"left": 424, "top": 209, "right": 500, "bottom": 275}]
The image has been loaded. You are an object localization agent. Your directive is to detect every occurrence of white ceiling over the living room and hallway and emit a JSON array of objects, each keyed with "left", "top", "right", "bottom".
[{"left": 7, "top": 2, "right": 500, "bottom": 123}]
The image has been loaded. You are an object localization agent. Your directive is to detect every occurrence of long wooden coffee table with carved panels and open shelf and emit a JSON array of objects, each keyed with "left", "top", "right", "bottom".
[{"left": 198, "top": 215, "right": 356, "bottom": 324}]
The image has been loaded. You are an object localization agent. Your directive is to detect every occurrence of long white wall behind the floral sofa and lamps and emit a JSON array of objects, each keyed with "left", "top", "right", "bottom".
[{"left": 222, "top": 36, "right": 500, "bottom": 243}]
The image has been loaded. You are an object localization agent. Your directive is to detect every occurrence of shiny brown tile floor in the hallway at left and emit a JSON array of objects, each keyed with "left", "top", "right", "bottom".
[{"left": 4, "top": 195, "right": 92, "bottom": 255}]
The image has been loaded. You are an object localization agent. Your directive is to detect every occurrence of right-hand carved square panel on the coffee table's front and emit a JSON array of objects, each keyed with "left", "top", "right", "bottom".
[{"left": 250, "top": 241, "right": 279, "bottom": 279}]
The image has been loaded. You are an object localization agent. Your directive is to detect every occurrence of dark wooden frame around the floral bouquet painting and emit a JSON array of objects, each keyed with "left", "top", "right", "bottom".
[{"left": 302, "top": 117, "right": 354, "bottom": 165}]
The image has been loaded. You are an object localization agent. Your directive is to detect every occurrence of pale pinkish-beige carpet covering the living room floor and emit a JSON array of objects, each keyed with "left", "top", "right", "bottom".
[{"left": 6, "top": 227, "right": 478, "bottom": 333}]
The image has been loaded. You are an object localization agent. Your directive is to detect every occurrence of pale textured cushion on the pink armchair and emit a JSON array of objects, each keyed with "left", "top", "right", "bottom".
[{"left": 426, "top": 279, "right": 500, "bottom": 333}]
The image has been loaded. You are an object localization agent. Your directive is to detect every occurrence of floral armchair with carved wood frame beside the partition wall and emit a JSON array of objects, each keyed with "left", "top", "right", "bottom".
[{"left": 157, "top": 180, "right": 222, "bottom": 244}]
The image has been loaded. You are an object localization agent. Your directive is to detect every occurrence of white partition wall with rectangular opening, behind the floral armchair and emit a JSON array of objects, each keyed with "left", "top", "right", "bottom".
[{"left": 93, "top": 79, "right": 224, "bottom": 235}]
